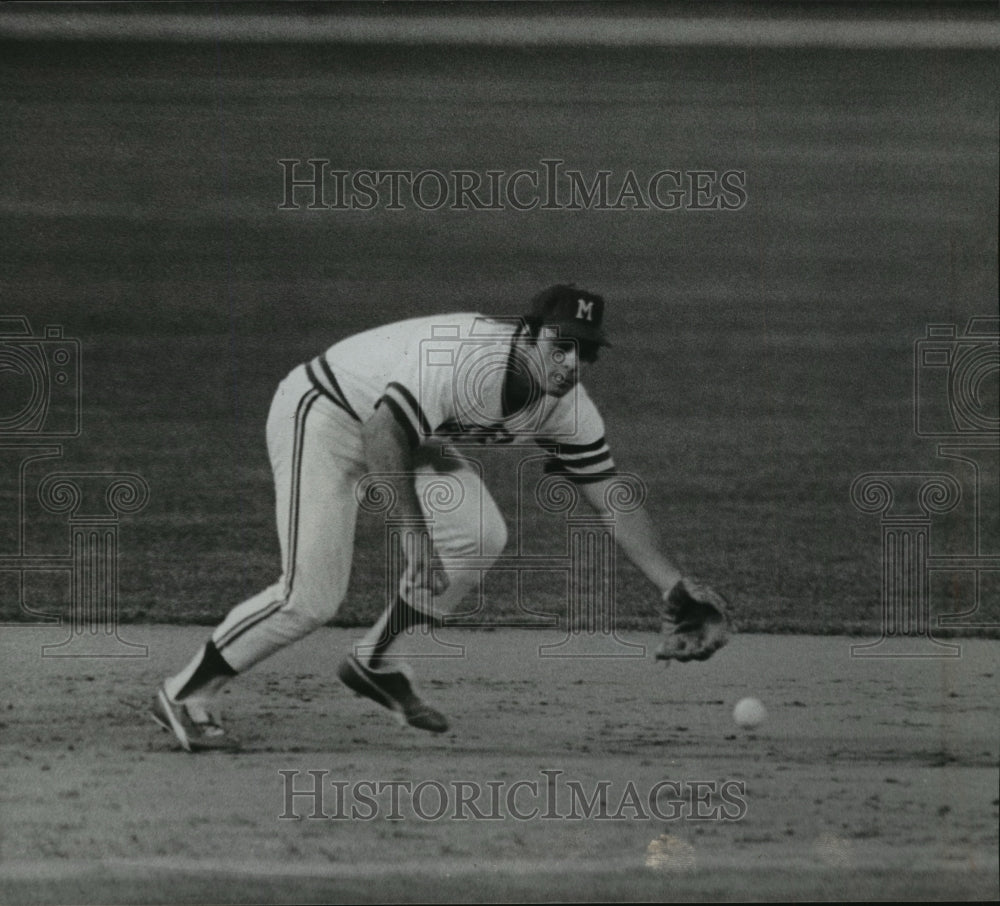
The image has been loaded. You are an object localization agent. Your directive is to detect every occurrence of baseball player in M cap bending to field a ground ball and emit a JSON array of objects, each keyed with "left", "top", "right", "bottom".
[{"left": 152, "top": 285, "right": 729, "bottom": 751}]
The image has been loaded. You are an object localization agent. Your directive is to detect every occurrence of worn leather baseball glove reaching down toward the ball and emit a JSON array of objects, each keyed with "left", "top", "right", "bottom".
[{"left": 656, "top": 581, "right": 732, "bottom": 661}]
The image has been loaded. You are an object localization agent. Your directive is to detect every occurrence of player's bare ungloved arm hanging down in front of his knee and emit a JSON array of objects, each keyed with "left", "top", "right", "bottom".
[{"left": 361, "top": 394, "right": 448, "bottom": 595}]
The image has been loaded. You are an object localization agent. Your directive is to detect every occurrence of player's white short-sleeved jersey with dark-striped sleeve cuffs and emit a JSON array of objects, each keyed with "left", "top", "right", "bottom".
[{"left": 306, "top": 312, "right": 615, "bottom": 482}]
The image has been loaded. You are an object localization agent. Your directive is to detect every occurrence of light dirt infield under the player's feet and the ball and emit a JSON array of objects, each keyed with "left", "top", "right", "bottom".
[{"left": 0, "top": 626, "right": 1000, "bottom": 903}]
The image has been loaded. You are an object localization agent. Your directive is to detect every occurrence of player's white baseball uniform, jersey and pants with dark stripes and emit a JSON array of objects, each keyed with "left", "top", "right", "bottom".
[{"left": 195, "top": 313, "right": 614, "bottom": 681}]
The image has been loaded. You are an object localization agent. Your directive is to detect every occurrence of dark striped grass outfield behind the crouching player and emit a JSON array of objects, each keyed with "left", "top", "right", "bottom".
[{"left": 0, "top": 43, "right": 1000, "bottom": 634}]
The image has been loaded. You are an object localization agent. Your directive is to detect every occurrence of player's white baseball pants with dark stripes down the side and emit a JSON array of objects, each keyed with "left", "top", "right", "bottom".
[{"left": 212, "top": 366, "right": 506, "bottom": 672}]
